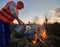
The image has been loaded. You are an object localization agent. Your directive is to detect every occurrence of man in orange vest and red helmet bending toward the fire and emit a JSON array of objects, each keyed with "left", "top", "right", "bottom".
[{"left": 0, "top": 1, "right": 24, "bottom": 47}]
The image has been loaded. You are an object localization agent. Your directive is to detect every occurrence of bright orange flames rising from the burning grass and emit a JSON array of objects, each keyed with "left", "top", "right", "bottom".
[{"left": 32, "top": 26, "right": 48, "bottom": 45}]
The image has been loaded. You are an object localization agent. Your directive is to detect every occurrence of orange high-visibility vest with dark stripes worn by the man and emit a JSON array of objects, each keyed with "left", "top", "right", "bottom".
[{"left": 0, "top": 3, "right": 18, "bottom": 23}]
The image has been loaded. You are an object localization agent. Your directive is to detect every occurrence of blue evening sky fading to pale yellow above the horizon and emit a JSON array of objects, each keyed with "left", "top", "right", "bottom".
[{"left": 0, "top": 0, "right": 60, "bottom": 22}]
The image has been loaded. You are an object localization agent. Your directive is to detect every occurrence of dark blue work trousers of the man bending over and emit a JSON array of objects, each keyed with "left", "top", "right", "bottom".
[{"left": 0, "top": 20, "right": 11, "bottom": 47}]
